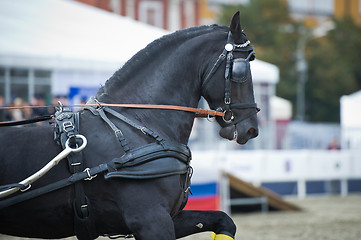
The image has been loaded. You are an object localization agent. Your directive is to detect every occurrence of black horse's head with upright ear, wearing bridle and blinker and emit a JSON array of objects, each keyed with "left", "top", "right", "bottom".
[{"left": 202, "top": 12, "right": 259, "bottom": 144}]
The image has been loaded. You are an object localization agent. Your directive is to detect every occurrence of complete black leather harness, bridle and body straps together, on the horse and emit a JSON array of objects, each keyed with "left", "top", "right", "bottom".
[{"left": 0, "top": 30, "right": 259, "bottom": 240}]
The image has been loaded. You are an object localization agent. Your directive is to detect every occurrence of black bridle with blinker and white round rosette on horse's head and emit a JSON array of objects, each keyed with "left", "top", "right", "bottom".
[{"left": 202, "top": 32, "right": 260, "bottom": 126}]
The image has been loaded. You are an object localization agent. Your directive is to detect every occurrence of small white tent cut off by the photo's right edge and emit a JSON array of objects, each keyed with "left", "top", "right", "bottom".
[{"left": 340, "top": 91, "right": 361, "bottom": 149}]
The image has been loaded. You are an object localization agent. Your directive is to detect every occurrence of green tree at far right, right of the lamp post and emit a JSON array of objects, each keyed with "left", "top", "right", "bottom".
[{"left": 306, "top": 19, "right": 361, "bottom": 122}]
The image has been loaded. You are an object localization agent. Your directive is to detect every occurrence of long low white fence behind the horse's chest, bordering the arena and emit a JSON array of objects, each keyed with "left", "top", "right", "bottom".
[{"left": 192, "top": 149, "right": 361, "bottom": 198}]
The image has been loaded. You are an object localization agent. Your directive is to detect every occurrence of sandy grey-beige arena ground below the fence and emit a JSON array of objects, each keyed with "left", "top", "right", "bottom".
[{"left": 0, "top": 194, "right": 361, "bottom": 240}]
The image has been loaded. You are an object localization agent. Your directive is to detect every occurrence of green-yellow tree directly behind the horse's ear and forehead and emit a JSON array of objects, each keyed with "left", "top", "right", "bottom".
[{"left": 219, "top": 0, "right": 298, "bottom": 118}]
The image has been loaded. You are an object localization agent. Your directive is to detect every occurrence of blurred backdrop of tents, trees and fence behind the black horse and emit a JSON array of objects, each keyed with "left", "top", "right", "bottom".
[{"left": 0, "top": 0, "right": 361, "bottom": 213}]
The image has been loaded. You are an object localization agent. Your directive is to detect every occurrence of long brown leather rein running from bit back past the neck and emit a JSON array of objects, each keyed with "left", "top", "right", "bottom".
[{"left": 0, "top": 103, "right": 224, "bottom": 123}]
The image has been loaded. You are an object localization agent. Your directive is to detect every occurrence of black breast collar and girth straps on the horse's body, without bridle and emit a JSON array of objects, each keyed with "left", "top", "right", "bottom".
[{"left": 0, "top": 103, "right": 192, "bottom": 239}]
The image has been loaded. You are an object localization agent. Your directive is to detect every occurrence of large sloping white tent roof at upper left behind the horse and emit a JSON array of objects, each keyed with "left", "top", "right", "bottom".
[{"left": 0, "top": 0, "right": 167, "bottom": 71}]
